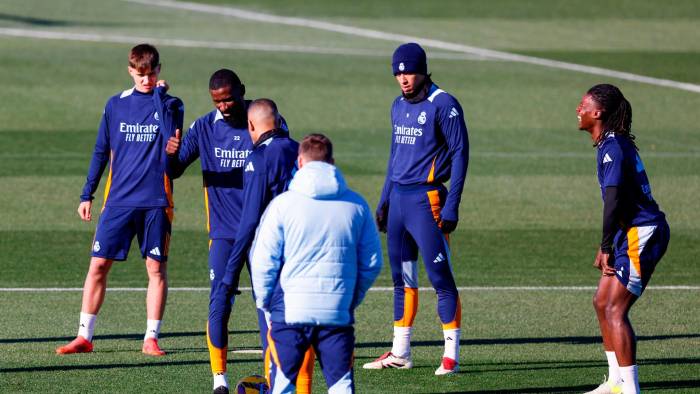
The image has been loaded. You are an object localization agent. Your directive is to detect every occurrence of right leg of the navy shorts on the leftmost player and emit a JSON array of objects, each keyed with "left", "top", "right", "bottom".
[{"left": 134, "top": 208, "right": 172, "bottom": 262}]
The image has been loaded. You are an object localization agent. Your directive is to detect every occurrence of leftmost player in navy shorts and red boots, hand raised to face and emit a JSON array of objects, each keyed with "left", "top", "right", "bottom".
[{"left": 56, "top": 44, "right": 184, "bottom": 356}]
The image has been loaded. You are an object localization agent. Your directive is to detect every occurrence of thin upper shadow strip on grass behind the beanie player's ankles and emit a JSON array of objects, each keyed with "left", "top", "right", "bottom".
[{"left": 355, "top": 334, "right": 700, "bottom": 348}]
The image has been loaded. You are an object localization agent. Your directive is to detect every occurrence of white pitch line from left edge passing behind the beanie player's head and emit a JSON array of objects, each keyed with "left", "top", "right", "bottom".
[{"left": 0, "top": 28, "right": 486, "bottom": 60}]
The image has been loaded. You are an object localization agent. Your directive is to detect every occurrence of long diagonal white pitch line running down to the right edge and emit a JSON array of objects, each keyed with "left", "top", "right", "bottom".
[{"left": 125, "top": 0, "right": 700, "bottom": 93}]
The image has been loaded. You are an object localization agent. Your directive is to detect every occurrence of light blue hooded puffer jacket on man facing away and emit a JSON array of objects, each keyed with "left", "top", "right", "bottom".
[{"left": 250, "top": 161, "right": 382, "bottom": 326}]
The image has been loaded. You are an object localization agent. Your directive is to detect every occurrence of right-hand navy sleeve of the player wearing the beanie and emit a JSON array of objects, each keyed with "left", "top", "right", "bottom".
[{"left": 438, "top": 99, "right": 469, "bottom": 220}]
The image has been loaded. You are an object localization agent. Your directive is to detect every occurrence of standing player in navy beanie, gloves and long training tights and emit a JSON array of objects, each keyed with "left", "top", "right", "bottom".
[{"left": 363, "top": 43, "right": 469, "bottom": 375}]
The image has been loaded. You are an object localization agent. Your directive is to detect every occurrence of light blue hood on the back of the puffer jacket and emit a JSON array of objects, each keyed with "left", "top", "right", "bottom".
[{"left": 289, "top": 161, "right": 347, "bottom": 200}]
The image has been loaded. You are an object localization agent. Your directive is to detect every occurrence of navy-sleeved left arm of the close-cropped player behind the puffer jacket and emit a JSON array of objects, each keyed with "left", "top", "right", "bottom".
[{"left": 222, "top": 152, "right": 267, "bottom": 290}]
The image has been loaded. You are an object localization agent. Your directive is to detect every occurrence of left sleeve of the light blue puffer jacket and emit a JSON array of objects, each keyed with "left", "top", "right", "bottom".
[{"left": 250, "top": 200, "right": 284, "bottom": 311}]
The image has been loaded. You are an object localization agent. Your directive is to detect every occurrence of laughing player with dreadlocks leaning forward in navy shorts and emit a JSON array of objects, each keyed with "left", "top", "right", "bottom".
[{"left": 576, "top": 84, "right": 670, "bottom": 394}]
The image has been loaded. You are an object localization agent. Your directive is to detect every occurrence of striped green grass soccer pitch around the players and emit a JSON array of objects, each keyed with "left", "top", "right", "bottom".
[{"left": 0, "top": 0, "right": 700, "bottom": 393}]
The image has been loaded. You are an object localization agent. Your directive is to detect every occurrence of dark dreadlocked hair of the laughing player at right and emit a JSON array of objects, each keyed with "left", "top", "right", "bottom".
[{"left": 587, "top": 84, "right": 639, "bottom": 150}]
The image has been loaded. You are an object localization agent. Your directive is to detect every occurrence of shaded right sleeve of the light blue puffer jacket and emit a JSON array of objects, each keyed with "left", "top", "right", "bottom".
[{"left": 353, "top": 205, "right": 382, "bottom": 308}]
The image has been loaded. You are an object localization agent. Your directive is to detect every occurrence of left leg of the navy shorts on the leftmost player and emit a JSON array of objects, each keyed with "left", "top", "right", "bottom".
[{"left": 92, "top": 207, "right": 135, "bottom": 261}]
